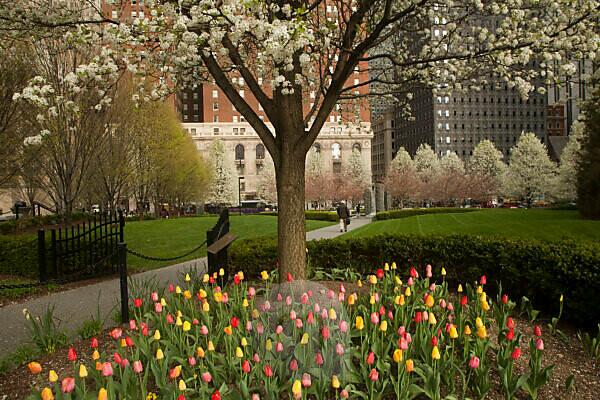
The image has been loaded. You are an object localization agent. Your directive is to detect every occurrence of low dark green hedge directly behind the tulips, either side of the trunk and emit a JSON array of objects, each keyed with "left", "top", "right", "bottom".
[{"left": 229, "top": 235, "right": 600, "bottom": 326}]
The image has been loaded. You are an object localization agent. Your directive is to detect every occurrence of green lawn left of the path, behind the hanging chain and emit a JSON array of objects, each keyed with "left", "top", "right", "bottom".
[{"left": 125, "top": 215, "right": 334, "bottom": 270}]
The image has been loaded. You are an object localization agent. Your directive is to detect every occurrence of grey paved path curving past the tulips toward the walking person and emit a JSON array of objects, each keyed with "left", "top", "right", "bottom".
[{"left": 0, "top": 217, "right": 371, "bottom": 356}]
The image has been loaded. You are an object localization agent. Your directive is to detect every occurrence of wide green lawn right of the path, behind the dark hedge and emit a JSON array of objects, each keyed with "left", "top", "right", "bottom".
[{"left": 343, "top": 209, "right": 600, "bottom": 241}]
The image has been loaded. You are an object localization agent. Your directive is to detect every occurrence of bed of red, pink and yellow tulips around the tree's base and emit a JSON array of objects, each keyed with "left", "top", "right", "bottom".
[{"left": 28, "top": 264, "right": 552, "bottom": 400}]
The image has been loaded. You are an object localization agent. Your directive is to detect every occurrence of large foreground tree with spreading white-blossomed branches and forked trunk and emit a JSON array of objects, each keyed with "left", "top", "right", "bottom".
[{"left": 0, "top": 0, "right": 599, "bottom": 277}]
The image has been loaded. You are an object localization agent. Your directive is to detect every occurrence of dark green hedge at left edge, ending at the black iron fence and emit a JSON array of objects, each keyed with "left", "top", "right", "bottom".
[{"left": 0, "top": 235, "right": 38, "bottom": 278}]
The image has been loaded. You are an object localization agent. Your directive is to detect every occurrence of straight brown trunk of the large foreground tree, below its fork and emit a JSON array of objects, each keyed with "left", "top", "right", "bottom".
[{"left": 276, "top": 149, "right": 306, "bottom": 282}]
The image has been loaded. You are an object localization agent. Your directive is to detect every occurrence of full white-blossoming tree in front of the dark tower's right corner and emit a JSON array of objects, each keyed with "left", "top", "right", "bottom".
[{"left": 505, "top": 132, "right": 556, "bottom": 205}]
